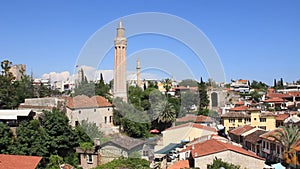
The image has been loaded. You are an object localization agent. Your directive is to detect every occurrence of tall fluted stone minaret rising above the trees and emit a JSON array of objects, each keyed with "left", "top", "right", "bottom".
[{"left": 113, "top": 19, "right": 127, "bottom": 102}]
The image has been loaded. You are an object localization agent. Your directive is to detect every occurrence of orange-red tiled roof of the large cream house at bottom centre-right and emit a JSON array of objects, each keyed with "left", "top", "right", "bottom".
[{"left": 187, "top": 139, "right": 264, "bottom": 160}]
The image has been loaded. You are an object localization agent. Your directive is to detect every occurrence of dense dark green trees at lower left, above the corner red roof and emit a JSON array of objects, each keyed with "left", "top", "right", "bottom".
[{"left": 0, "top": 110, "right": 91, "bottom": 168}]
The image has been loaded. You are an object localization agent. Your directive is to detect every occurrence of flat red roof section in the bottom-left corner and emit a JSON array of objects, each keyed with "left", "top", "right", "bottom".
[{"left": 0, "top": 154, "right": 42, "bottom": 169}]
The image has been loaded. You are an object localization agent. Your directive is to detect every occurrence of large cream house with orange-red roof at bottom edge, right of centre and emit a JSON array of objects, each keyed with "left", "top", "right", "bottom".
[{"left": 181, "top": 139, "right": 265, "bottom": 169}]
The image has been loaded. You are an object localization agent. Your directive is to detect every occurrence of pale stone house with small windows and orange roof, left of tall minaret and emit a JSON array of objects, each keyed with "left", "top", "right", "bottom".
[{"left": 66, "top": 95, "right": 113, "bottom": 133}]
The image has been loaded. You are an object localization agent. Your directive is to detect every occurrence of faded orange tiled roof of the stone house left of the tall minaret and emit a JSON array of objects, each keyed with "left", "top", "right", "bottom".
[{"left": 66, "top": 95, "right": 112, "bottom": 109}]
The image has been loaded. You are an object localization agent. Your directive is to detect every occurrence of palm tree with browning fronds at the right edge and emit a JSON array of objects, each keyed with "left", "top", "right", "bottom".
[{"left": 270, "top": 126, "right": 300, "bottom": 167}]
